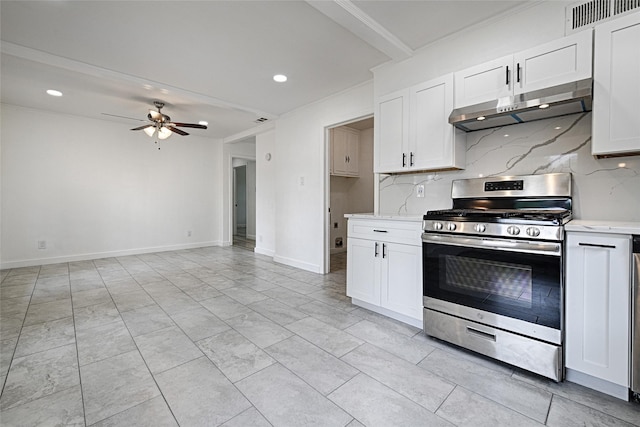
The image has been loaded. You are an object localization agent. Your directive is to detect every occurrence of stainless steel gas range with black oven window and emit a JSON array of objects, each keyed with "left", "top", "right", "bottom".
[{"left": 422, "top": 173, "right": 572, "bottom": 381}]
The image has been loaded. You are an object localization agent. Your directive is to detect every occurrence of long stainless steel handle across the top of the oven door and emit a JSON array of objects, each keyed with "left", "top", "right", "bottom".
[{"left": 422, "top": 233, "right": 562, "bottom": 256}]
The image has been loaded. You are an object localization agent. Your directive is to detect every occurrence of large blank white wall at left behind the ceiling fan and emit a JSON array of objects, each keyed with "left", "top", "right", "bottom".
[{"left": 0, "top": 104, "right": 222, "bottom": 268}]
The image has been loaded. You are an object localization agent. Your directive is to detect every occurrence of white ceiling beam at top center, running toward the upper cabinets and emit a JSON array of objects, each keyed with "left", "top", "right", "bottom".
[{"left": 307, "top": 0, "right": 414, "bottom": 61}]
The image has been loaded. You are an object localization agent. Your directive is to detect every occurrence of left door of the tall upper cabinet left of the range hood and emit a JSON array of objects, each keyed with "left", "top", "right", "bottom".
[{"left": 374, "top": 89, "right": 409, "bottom": 173}]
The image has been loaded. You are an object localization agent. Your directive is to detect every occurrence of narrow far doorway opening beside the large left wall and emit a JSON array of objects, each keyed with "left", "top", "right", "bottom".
[{"left": 232, "top": 158, "right": 256, "bottom": 251}]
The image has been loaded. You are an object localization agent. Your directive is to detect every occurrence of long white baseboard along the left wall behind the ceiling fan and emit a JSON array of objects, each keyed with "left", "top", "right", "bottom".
[{"left": 0, "top": 241, "right": 224, "bottom": 270}]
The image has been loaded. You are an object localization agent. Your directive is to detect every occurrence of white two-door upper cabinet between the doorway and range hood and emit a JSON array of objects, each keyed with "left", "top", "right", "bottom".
[{"left": 375, "top": 74, "right": 465, "bottom": 173}]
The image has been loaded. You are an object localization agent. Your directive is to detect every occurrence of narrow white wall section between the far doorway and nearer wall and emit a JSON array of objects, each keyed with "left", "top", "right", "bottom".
[{"left": 255, "top": 129, "right": 277, "bottom": 256}]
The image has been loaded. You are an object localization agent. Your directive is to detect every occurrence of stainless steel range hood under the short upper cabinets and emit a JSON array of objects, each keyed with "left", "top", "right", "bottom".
[{"left": 449, "top": 79, "right": 593, "bottom": 132}]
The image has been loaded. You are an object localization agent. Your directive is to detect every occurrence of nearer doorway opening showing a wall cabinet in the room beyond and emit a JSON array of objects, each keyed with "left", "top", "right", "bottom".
[{"left": 325, "top": 117, "right": 375, "bottom": 273}]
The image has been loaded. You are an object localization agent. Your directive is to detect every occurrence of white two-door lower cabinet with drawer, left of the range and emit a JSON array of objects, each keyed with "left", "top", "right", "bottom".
[{"left": 347, "top": 219, "right": 422, "bottom": 327}]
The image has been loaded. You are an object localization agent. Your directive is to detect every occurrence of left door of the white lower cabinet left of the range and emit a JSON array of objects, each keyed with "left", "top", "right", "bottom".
[{"left": 347, "top": 237, "right": 382, "bottom": 305}]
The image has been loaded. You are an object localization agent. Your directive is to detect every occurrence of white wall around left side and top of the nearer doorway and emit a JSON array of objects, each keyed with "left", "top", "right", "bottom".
[{"left": 272, "top": 82, "right": 373, "bottom": 273}]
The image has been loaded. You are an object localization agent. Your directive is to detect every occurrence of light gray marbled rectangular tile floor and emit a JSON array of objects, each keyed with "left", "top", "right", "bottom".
[{"left": 0, "top": 247, "right": 640, "bottom": 427}]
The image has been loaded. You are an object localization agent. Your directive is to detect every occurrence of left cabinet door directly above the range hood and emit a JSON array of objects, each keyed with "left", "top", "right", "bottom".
[{"left": 454, "top": 55, "right": 513, "bottom": 108}]
